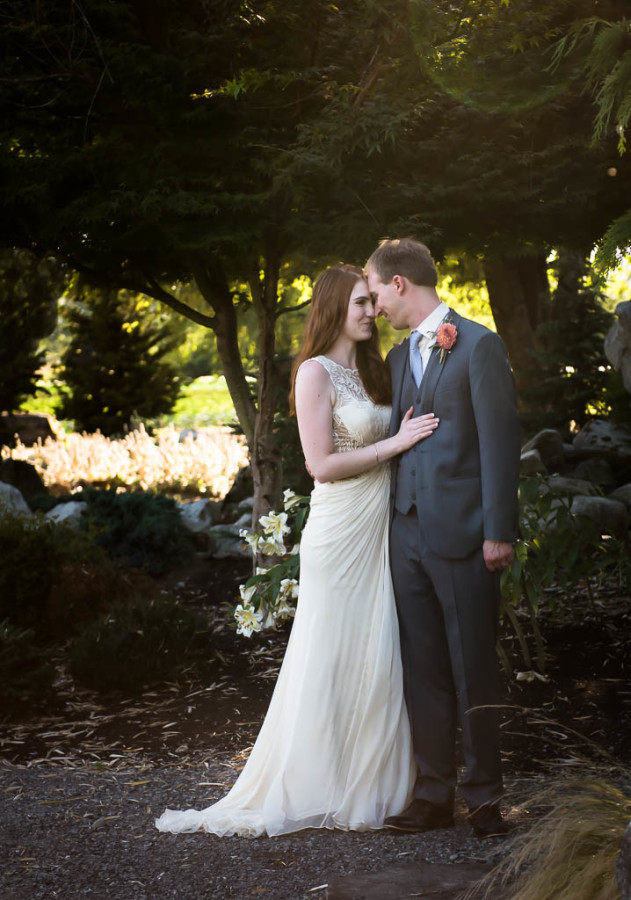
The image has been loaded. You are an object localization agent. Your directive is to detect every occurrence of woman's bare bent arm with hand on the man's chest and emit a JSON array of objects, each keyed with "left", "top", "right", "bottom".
[{"left": 295, "top": 360, "right": 438, "bottom": 482}]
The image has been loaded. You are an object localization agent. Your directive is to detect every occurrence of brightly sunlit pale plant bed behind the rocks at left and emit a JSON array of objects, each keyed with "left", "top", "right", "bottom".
[{"left": 2, "top": 424, "right": 248, "bottom": 497}]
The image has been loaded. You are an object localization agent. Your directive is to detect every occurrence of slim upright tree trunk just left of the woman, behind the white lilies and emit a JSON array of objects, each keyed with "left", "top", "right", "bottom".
[{"left": 249, "top": 242, "right": 283, "bottom": 524}]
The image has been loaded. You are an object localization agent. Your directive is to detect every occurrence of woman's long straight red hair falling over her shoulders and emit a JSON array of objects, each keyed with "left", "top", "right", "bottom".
[{"left": 289, "top": 265, "right": 392, "bottom": 415}]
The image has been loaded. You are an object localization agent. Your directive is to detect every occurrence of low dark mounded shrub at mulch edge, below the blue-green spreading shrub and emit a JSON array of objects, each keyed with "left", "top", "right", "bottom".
[{"left": 69, "top": 597, "right": 211, "bottom": 693}]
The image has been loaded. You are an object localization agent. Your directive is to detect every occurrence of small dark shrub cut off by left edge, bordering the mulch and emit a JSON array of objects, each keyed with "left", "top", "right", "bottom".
[{"left": 0, "top": 619, "right": 55, "bottom": 709}]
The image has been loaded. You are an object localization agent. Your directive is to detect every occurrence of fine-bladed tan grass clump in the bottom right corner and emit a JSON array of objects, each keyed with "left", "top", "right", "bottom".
[{"left": 468, "top": 771, "right": 631, "bottom": 900}]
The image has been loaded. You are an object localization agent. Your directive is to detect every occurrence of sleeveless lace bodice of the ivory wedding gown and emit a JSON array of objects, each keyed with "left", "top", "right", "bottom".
[{"left": 306, "top": 356, "right": 390, "bottom": 453}]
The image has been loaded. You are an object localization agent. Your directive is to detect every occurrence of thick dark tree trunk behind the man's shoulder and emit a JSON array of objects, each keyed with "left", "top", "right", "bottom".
[{"left": 484, "top": 255, "right": 550, "bottom": 389}]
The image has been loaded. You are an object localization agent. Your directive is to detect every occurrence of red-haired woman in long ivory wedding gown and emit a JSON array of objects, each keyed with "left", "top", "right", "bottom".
[{"left": 156, "top": 265, "right": 438, "bottom": 837}]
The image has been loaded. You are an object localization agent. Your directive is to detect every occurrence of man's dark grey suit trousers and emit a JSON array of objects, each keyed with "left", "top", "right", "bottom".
[{"left": 390, "top": 507, "right": 502, "bottom": 808}]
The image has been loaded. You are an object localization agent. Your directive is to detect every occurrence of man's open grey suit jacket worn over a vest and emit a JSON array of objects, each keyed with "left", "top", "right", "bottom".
[{"left": 387, "top": 310, "right": 521, "bottom": 559}]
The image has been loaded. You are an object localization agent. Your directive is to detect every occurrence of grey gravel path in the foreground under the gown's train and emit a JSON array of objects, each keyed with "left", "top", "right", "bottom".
[{"left": 0, "top": 752, "right": 520, "bottom": 900}]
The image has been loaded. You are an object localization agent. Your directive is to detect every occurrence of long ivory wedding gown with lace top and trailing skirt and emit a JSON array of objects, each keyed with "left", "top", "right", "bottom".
[{"left": 156, "top": 356, "right": 415, "bottom": 837}]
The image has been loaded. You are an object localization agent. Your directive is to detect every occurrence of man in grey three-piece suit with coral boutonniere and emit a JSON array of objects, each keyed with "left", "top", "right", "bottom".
[{"left": 366, "top": 238, "right": 520, "bottom": 837}]
